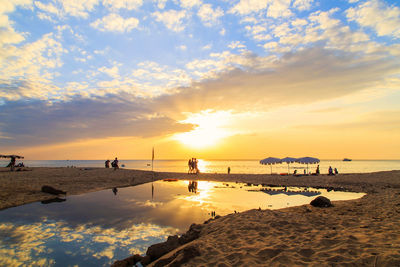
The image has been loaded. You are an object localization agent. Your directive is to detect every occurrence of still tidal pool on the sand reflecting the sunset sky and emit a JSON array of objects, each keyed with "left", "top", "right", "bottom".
[{"left": 0, "top": 181, "right": 364, "bottom": 266}]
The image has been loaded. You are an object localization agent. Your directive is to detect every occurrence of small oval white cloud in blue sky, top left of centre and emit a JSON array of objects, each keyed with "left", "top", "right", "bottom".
[{"left": 90, "top": 13, "right": 139, "bottom": 32}]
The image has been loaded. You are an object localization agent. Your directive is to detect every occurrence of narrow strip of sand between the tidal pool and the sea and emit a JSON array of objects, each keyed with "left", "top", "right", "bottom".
[{"left": 0, "top": 167, "right": 400, "bottom": 210}]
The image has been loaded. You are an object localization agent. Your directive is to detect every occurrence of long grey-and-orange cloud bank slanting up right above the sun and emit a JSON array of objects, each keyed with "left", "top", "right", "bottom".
[{"left": 157, "top": 47, "right": 399, "bottom": 112}]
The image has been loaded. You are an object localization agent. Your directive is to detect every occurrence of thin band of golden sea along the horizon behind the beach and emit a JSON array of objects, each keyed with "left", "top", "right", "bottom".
[{"left": 0, "top": 159, "right": 400, "bottom": 174}]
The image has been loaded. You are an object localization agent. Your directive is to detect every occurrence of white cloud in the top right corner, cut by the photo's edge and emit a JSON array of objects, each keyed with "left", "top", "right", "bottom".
[{"left": 346, "top": 0, "right": 400, "bottom": 38}]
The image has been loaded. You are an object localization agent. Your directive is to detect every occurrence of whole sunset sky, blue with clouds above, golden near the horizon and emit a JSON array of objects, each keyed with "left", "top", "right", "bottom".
[{"left": 0, "top": 0, "right": 400, "bottom": 160}]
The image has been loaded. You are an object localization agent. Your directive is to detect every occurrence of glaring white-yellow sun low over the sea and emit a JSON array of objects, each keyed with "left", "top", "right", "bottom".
[{"left": 172, "top": 110, "right": 232, "bottom": 149}]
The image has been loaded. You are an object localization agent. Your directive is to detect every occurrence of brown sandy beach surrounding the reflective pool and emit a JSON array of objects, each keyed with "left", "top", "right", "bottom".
[{"left": 0, "top": 168, "right": 400, "bottom": 266}]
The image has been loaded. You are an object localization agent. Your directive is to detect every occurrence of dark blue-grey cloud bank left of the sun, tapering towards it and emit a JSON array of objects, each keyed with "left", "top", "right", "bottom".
[{"left": 0, "top": 94, "right": 192, "bottom": 146}]
